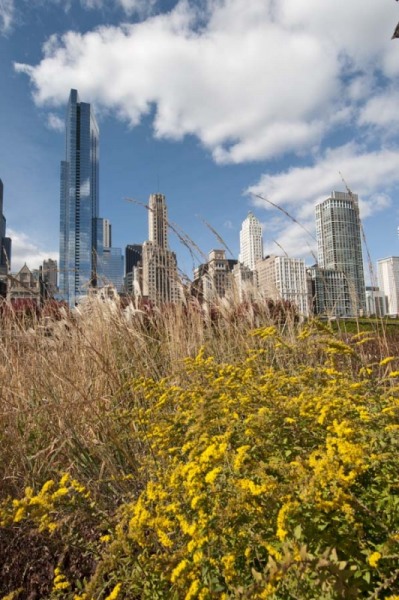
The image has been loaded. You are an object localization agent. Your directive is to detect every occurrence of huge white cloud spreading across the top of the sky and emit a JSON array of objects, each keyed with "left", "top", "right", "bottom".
[{"left": 16, "top": 0, "right": 399, "bottom": 163}]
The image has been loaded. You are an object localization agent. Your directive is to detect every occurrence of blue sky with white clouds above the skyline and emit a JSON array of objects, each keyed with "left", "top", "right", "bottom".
[{"left": 0, "top": 0, "right": 399, "bottom": 277}]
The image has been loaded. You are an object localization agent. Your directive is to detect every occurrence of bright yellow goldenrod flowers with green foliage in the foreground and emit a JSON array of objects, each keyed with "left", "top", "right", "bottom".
[{"left": 1, "top": 326, "right": 399, "bottom": 600}]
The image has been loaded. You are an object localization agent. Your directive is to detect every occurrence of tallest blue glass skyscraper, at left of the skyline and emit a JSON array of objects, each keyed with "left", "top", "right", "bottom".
[{"left": 59, "top": 90, "right": 99, "bottom": 306}]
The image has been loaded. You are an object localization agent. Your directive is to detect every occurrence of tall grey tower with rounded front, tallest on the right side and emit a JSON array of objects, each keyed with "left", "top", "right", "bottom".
[{"left": 316, "top": 192, "right": 366, "bottom": 316}]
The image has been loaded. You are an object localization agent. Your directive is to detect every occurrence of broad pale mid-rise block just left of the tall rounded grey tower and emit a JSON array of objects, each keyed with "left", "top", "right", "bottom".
[{"left": 256, "top": 256, "right": 309, "bottom": 316}]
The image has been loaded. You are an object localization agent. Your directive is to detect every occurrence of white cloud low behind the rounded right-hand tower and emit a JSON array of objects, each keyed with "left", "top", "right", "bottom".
[{"left": 246, "top": 144, "right": 399, "bottom": 257}]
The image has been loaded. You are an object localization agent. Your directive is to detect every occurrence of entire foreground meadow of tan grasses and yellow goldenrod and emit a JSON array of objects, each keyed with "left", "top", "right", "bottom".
[{"left": 0, "top": 299, "right": 399, "bottom": 600}]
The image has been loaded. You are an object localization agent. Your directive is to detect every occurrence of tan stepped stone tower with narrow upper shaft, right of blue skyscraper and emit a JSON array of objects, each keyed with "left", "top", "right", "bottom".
[{"left": 142, "top": 194, "right": 181, "bottom": 304}]
